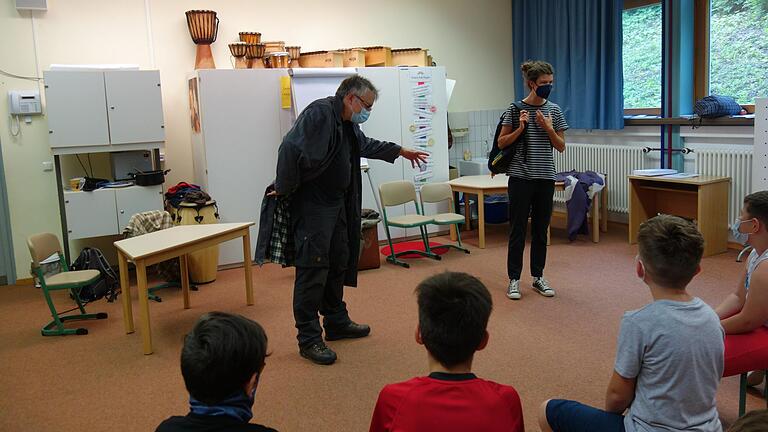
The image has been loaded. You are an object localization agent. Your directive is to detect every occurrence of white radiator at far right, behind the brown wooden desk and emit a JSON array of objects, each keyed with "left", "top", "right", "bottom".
[{"left": 693, "top": 147, "right": 752, "bottom": 223}]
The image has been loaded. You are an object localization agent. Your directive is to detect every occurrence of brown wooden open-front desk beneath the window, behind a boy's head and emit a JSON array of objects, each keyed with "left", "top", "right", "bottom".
[{"left": 627, "top": 176, "right": 731, "bottom": 256}]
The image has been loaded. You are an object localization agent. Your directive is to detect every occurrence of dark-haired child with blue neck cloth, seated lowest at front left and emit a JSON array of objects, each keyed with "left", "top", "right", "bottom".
[{"left": 156, "top": 312, "right": 275, "bottom": 432}]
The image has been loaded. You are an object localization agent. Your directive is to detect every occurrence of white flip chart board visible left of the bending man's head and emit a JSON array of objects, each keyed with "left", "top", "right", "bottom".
[{"left": 289, "top": 68, "right": 357, "bottom": 117}]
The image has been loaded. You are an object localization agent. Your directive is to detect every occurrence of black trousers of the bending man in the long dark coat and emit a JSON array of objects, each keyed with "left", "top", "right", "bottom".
[{"left": 293, "top": 207, "right": 350, "bottom": 346}]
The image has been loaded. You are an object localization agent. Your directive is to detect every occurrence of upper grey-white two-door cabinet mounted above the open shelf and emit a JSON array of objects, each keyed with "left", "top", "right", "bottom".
[{"left": 45, "top": 71, "right": 165, "bottom": 154}]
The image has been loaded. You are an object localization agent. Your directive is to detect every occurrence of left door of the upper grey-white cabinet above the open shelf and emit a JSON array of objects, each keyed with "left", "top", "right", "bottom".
[{"left": 45, "top": 71, "right": 109, "bottom": 148}]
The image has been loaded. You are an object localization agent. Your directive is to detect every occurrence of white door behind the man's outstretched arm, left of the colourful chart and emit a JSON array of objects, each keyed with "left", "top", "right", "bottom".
[{"left": 358, "top": 68, "right": 414, "bottom": 240}]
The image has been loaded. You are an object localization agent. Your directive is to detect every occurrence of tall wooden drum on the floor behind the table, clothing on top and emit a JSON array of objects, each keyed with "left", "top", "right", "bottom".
[{"left": 175, "top": 200, "right": 219, "bottom": 284}]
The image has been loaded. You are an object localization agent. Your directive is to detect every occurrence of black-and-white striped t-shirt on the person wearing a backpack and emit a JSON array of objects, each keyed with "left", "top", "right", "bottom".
[{"left": 503, "top": 101, "right": 568, "bottom": 180}]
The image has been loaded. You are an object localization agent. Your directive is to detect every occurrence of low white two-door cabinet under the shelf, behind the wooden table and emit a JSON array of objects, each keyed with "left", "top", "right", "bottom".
[{"left": 64, "top": 185, "right": 163, "bottom": 239}]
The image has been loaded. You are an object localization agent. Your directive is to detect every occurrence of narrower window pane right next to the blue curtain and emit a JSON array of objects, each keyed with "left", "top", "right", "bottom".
[{"left": 622, "top": 2, "right": 661, "bottom": 109}]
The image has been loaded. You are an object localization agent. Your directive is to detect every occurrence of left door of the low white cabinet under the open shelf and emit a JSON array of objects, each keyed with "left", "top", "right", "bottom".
[{"left": 64, "top": 189, "right": 118, "bottom": 240}]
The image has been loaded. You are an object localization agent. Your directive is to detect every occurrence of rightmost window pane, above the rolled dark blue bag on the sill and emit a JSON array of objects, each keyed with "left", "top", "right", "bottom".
[{"left": 708, "top": 0, "right": 768, "bottom": 104}]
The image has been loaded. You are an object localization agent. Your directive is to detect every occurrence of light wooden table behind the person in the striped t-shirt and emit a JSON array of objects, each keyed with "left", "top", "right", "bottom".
[{"left": 448, "top": 174, "right": 608, "bottom": 249}]
